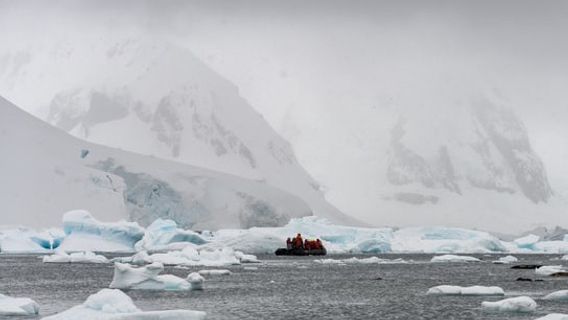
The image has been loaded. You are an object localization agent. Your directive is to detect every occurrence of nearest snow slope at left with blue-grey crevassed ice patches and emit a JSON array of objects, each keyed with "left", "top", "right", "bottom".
[{"left": 0, "top": 98, "right": 312, "bottom": 229}]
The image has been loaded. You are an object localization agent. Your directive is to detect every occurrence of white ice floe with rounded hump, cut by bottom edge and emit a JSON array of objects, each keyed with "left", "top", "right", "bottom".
[{"left": 43, "top": 289, "right": 206, "bottom": 320}]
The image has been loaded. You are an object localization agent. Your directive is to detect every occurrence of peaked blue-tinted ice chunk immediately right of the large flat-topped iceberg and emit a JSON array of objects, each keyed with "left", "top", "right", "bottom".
[{"left": 135, "top": 219, "right": 205, "bottom": 251}]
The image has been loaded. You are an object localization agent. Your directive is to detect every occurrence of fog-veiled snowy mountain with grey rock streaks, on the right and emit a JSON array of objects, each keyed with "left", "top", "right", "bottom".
[{"left": 366, "top": 94, "right": 568, "bottom": 232}]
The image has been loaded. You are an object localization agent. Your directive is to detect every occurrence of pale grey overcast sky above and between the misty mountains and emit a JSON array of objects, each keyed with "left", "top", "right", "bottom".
[{"left": 0, "top": 0, "right": 568, "bottom": 220}]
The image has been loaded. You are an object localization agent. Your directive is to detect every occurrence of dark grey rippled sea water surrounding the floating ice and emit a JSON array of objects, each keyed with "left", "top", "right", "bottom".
[{"left": 0, "top": 254, "right": 568, "bottom": 319}]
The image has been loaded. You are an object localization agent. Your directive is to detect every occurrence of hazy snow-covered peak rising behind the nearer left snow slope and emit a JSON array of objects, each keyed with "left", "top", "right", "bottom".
[{"left": 0, "top": 36, "right": 352, "bottom": 223}]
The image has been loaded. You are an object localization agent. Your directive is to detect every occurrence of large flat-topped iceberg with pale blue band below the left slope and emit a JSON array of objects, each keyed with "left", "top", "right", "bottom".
[{"left": 60, "top": 210, "right": 144, "bottom": 252}]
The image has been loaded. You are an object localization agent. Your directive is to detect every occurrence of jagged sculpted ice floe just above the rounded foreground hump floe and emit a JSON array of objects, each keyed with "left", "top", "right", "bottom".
[{"left": 109, "top": 262, "right": 201, "bottom": 291}]
